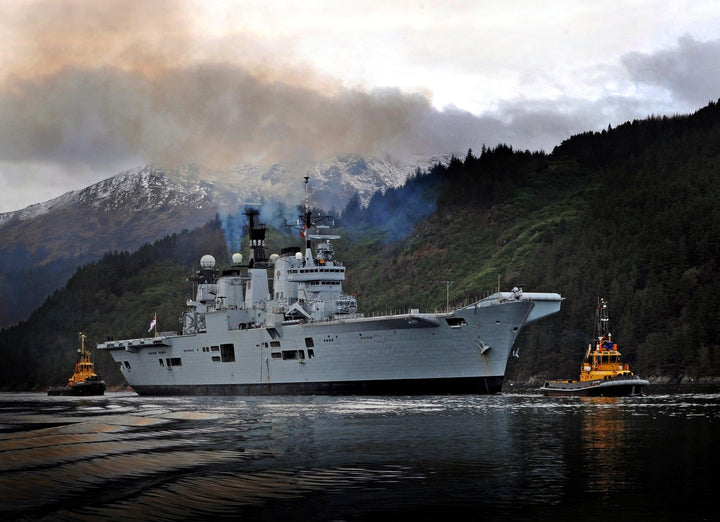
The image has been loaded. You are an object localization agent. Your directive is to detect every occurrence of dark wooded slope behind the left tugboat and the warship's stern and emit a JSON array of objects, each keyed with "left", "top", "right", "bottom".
[{"left": 0, "top": 219, "right": 228, "bottom": 390}]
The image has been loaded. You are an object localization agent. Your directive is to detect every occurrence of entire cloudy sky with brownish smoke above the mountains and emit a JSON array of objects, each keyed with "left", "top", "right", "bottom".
[{"left": 0, "top": 0, "right": 720, "bottom": 212}]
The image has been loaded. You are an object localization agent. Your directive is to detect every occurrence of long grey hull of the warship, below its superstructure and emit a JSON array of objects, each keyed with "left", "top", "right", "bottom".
[{"left": 99, "top": 292, "right": 561, "bottom": 395}]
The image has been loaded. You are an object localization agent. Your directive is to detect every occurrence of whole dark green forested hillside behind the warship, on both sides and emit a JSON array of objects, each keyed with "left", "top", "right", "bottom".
[{"left": 0, "top": 99, "right": 720, "bottom": 389}]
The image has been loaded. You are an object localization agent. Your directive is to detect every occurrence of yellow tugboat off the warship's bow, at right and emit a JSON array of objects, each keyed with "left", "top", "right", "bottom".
[{"left": 540, "top": 299, "right": 650, "bottom": 397}]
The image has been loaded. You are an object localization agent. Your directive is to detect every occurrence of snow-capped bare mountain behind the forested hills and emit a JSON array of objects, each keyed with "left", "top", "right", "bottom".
[{"left": 0, "top": 154, "right": 449, "bottom": 327}]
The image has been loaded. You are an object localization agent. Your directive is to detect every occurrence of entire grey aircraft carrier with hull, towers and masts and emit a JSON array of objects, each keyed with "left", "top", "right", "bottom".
[{"left": 98, "top": 177, "right": 562, "bottom": 395}]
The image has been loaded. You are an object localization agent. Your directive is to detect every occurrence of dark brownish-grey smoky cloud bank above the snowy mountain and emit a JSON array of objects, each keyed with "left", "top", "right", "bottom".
[{"left": 0, "top": 65, "right": 442, "bottom": 167}]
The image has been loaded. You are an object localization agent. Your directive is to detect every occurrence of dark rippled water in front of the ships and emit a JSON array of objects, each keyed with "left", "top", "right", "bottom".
[{"left": 0, "top": 386, "right": 720, "bottom": 520}]
